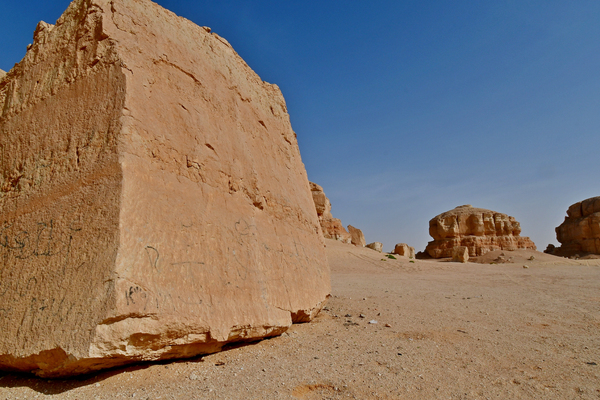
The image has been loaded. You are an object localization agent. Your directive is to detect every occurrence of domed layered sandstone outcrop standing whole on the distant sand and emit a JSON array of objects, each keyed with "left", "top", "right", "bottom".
[{"left": 425, "top": 205, "right": 536, "bottom": 258}]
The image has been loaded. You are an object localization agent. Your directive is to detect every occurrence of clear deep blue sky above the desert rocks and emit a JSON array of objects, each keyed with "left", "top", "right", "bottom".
[{"left": 0, "top": 0, "right": 600, "bottom": 251}]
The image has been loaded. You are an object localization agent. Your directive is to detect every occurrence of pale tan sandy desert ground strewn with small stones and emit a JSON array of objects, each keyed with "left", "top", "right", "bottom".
[{"left": 0, "top": 240, "right": 600, "bottom": 400}]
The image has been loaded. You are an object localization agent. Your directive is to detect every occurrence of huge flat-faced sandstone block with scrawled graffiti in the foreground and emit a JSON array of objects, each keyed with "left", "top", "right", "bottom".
[{"left": 0, "top": 0, "right": 330, "bottom": 377}]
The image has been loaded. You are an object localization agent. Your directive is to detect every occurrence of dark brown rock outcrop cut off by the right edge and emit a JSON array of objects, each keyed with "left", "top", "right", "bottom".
[{"left": 551, "top": 197, "right": 600, "bottom": 256}]
